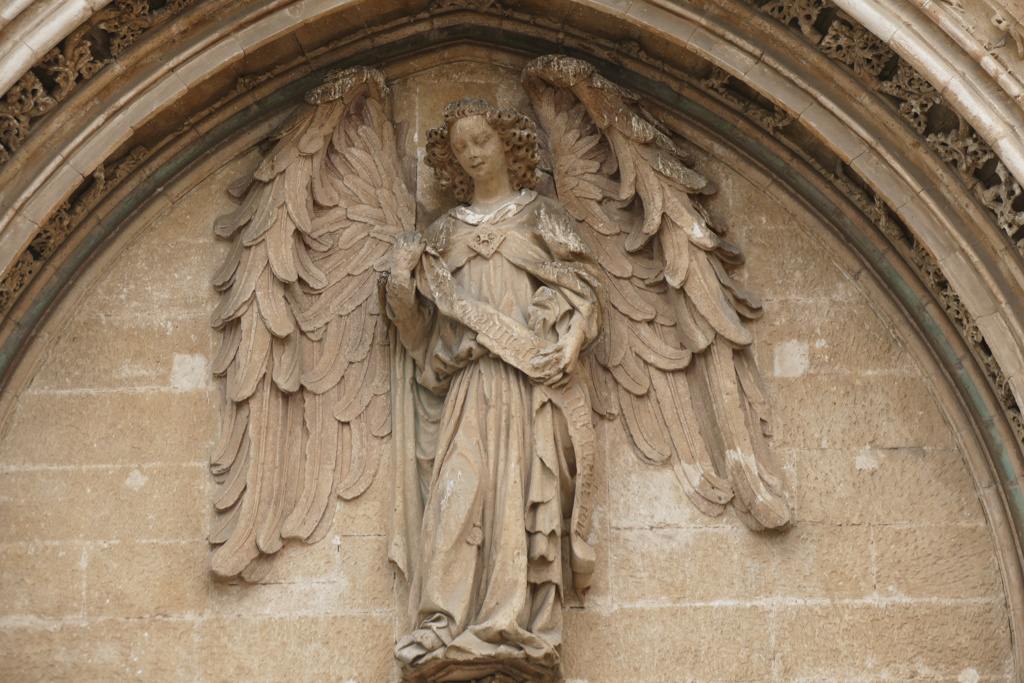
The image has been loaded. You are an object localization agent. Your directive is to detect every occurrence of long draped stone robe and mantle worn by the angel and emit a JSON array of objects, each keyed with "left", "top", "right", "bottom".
[{"left": 386, "top": 190, "right": 603, "bottom": 666}]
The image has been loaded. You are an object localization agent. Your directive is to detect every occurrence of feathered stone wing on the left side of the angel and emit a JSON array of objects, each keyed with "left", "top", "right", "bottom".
[{"left": 210, "top": 69, "right": 415, "bottom": 581}]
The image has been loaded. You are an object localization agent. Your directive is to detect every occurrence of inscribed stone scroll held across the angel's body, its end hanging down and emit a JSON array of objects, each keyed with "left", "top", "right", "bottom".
[{"left": 420, "top": 249, "right": 597, "bottom": 595}]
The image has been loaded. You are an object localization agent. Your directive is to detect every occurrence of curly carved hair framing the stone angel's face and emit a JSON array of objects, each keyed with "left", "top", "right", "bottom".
[{"left": 425, "top": 99, "right": 541, "bottom": 203}]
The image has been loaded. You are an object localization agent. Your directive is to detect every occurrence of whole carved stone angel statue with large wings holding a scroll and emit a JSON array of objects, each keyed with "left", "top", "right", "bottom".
[{"left": 210, "top": 56, "right": 791, "bottom": 682}]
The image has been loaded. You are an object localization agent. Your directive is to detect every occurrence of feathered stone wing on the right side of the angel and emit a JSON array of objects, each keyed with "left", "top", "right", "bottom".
[{"left": 523, "top": 55, "right": 790, "bottom": 529}]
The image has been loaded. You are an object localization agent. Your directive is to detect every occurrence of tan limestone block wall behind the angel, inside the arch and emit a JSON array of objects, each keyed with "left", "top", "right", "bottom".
[{"left": 0, "top": 60, "right": 1016, "bottom": 683}]
